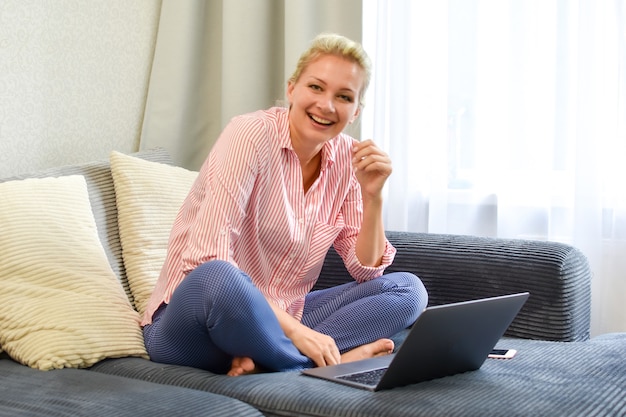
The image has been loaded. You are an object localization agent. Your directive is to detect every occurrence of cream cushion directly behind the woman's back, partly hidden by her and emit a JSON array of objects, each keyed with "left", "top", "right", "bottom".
[{"left": 110, "top": 151, "right": 198, "bottom": 315}]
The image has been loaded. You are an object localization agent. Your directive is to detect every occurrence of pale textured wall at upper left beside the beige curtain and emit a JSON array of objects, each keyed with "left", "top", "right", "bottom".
[{"left": 0, "top": 0, "right": 161, "bottom": 177}]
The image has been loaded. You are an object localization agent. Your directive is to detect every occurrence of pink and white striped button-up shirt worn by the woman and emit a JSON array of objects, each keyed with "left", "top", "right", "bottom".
[{"left": 143, "top": 108, "right": 396, "bottom": 325}]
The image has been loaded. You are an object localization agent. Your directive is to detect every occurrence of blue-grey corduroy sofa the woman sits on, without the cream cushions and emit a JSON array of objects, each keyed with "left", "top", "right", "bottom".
[{"left": 0, "top": 149, "right": 626, "bottom": 416}]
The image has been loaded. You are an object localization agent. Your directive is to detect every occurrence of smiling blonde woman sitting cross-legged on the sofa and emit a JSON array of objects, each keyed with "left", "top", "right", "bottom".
[{"left": 143, "top": 35, "right": 427, "bottom": 376}]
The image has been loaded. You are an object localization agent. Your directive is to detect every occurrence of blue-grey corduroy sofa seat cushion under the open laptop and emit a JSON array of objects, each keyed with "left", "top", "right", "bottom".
[{"left": 92, "top": 334, "right": 626, "bottom": 417}]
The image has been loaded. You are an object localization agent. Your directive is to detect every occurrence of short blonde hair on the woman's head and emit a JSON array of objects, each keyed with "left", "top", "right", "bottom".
[{"left": 289, "top": 33, "right": 372, "bottom": 107}]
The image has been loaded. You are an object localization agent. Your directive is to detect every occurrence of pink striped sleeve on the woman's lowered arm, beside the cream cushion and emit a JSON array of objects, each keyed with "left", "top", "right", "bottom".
[{"left": 182, "top": 117, "right": 266, "bottom": 274}]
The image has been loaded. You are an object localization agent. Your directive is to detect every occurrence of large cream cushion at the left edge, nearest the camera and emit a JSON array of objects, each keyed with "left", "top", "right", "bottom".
[{"left": 0, "top": 175, "right": 147, "bottom": 370}]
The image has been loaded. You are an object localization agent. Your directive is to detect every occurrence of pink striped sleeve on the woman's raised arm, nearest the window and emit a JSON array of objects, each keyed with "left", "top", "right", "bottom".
[{"left": 334, "top": 177, "right": 396, "bottom": 282}]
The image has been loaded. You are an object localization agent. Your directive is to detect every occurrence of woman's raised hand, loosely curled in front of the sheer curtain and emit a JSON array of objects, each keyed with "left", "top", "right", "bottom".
[{"left": 352, "top": 139, "right": 392, "bottom": 198}]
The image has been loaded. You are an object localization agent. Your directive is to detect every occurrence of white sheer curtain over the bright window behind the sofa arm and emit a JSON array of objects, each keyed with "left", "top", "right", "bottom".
[{"left": 362, "top": 0, "right": 626, "bottom": 334}]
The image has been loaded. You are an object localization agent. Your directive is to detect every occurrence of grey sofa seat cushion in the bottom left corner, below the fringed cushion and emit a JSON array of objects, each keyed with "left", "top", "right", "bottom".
[{"left": 0, "top": 359, "right": 261, "bottom": 417}]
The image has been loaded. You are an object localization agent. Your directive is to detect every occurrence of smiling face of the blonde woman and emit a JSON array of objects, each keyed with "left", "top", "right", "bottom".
[{"left": 287, "top": 55, "right": 364, "bottom": 150}]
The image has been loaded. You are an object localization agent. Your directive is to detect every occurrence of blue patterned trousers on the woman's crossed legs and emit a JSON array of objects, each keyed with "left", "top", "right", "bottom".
[{"left": 144, "top": 261, "right": 427, "bottom": 373}]
